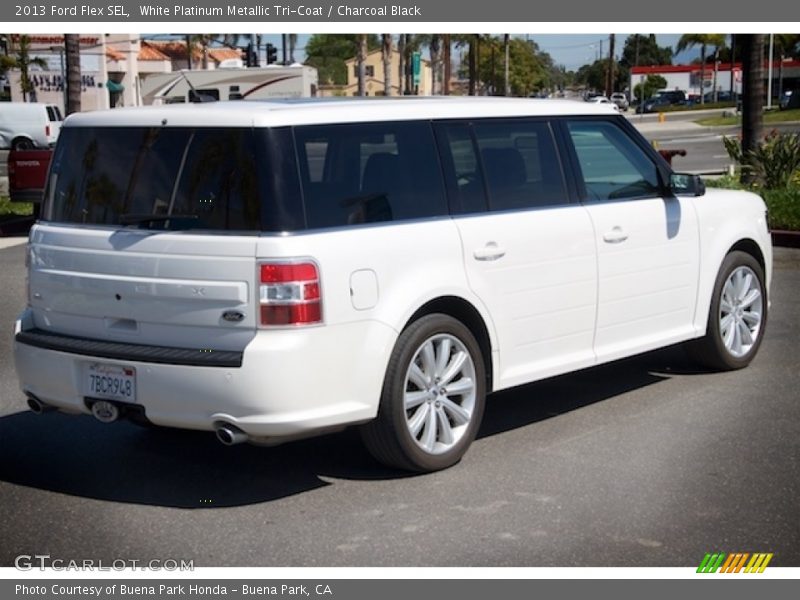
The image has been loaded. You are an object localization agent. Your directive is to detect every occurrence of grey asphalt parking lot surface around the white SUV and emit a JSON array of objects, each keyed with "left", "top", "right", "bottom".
[{"left": 0, "top": 240, "right": 800, "bottom": 567}]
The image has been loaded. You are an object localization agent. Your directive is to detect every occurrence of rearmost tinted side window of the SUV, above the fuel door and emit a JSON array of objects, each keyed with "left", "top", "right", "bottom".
[{"left": 295, "top": 122, "right": 447, "bottom": 228}]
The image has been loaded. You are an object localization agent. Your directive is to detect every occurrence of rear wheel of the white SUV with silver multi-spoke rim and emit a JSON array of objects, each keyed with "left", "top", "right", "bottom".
[{"left": 361, "top": 313, "right": 486, "bottom": 473}]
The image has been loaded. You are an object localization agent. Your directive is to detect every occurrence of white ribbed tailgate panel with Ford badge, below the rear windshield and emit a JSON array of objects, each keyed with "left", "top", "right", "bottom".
[{"left": 29, "top": 224, "right": 257, "bottom": 351}]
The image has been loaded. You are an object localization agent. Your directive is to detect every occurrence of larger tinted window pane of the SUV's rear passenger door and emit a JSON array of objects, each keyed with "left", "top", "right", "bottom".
[{"left": 473, "top": 120, "right": 568, "bottom": 211}]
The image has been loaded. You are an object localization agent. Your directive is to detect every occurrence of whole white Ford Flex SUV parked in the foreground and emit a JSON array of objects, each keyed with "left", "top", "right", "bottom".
[{"left": 15, "top": 98, "right": 772, "bottom": 471}]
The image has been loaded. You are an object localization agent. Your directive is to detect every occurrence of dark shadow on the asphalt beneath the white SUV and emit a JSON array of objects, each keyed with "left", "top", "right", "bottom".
[{"left": 0, "top": 342, "right": 682, "bottom": 509}]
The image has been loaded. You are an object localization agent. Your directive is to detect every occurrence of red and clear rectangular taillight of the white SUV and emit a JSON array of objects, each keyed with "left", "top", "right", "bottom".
[{"left": 259, "top": 262, "right": 322, "bottom": 327}]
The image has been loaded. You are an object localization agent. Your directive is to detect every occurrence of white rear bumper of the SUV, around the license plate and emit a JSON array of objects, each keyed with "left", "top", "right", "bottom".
[{"left": 14, "top": 311, "right": 397, "bottom": 441}]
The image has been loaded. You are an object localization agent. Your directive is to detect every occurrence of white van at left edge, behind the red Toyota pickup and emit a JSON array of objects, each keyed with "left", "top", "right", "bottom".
[{"left": 0, "top": 102, "right": 63, "bottom": 150}]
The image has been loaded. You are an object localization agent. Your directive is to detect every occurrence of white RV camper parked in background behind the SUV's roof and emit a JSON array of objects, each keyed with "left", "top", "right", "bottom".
[{"left": 142, "top": 65, "right": 317, "bottom": 104}]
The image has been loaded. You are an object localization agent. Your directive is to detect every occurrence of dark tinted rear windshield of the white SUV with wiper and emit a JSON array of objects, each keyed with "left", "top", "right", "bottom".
[{"left": 45, "top": 127, "right": 265, "bottom": 231}]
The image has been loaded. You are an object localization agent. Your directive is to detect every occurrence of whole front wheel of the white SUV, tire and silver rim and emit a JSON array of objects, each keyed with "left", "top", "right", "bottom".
[{"left": 689, "top": 251, "right": 767, "bottom": 371}]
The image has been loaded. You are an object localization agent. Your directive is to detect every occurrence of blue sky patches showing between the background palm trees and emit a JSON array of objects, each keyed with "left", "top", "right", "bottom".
[{"left": 255, "top": 33, "right": 700, "bottom": 70}]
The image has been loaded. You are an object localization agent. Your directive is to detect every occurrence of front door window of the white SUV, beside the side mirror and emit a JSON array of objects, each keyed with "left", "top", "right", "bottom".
[{"left": 568, "top": 120, "right": 661, "bottom": 200}]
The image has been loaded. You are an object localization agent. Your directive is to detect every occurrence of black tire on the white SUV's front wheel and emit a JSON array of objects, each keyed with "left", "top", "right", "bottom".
[{"left": 687, "top": 251, "right": 768, "bottom": 371}]
